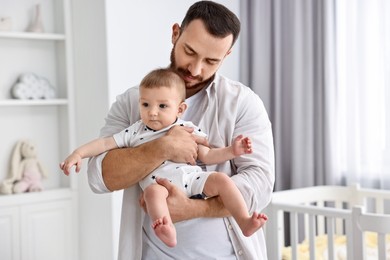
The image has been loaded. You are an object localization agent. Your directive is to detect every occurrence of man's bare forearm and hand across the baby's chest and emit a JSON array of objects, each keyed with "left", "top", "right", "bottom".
[{"left": 102, "top": 126, "right": 199, "bottom": 191}]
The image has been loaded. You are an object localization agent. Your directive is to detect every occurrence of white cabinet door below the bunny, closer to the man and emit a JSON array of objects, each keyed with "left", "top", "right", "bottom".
[{"left": 20, "top": 200, "right": 73, "bottom": 260}]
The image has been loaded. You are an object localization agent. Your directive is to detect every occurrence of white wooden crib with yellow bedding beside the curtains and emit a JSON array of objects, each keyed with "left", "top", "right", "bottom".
[{"left": 264, "top": 185, "right": 390, "bottom": 260}]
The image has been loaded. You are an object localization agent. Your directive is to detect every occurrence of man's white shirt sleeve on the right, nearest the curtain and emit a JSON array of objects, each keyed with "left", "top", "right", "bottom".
[{"left": 232, "top": 91, "right": 275, "bottom": 212}]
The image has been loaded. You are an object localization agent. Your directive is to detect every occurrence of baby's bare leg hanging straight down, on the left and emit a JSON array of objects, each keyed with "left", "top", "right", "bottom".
[{"left": 144, "top": 184, "right": 177, "bottom": 247}]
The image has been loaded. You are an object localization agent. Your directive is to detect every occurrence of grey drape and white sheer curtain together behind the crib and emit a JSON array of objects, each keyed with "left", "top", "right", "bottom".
[{"left": 240, "top": 0, "right": 390, "bottom": 190}]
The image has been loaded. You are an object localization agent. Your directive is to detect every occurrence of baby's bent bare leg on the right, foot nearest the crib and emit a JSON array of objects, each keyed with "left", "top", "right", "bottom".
[{"left": 204, "top": 172, "right": 267, "bottom": 236}]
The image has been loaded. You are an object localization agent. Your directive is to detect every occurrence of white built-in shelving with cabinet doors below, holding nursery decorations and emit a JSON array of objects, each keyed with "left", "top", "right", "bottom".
[{"left": 0, "top": 0, "right": 78, "bottom": 260}]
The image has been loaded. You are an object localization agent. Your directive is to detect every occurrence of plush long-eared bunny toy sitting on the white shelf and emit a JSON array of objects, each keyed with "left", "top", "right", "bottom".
[{"left": 0, "top": 140, "right": 47, "bottom": 194}]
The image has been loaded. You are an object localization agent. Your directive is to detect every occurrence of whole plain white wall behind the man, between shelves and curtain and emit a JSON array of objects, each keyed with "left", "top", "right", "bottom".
[{"left": 73, "top": 0, "right": 239, "bottom": 260}]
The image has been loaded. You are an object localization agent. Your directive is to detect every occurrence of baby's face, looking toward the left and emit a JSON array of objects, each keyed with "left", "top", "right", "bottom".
[{"left": 139, "top": 86, "right": 181, "bottom": 130}]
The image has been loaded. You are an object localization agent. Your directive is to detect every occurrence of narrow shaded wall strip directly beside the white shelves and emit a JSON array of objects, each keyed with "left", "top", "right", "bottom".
[{"left": 72, "top": 0, "right": 117, "bottom": 260}]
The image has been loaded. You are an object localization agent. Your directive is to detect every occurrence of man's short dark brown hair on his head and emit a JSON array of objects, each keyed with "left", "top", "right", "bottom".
[{"left": 180, "top": 1, "right": 241, "bottom": 46}]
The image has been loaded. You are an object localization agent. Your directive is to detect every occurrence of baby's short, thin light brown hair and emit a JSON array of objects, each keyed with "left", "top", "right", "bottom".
[{"left": 140, "top": 68, "right": 186, "bottom": 101}]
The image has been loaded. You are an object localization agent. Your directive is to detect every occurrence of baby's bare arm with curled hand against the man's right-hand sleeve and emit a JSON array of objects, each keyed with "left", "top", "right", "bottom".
[{"left": 198, "top": 135, "right": 252, "bottom": 164}]
